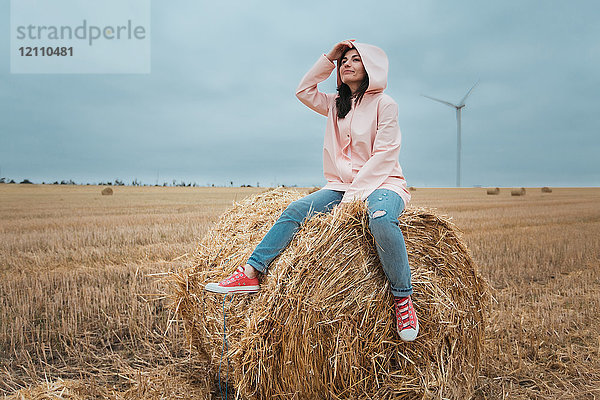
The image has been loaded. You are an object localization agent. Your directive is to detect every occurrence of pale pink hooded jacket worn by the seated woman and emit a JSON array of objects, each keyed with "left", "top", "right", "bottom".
[{"left": 296, "top": 42, "right": 410, "bottom": 206}]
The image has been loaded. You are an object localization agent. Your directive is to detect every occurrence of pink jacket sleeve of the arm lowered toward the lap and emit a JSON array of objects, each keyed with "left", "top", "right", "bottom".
[{"left": 342, "top": 102, "right": 401, "bottom": 203}]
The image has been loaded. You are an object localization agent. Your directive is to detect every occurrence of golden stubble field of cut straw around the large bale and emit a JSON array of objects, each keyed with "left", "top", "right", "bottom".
[{"left": 0, "top": 184, "right": 600, "bottom": 399}]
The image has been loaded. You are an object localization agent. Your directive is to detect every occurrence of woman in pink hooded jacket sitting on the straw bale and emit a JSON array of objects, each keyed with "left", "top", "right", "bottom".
[{"left": 206, "top": 40, "right": 419, "bottom": 341}]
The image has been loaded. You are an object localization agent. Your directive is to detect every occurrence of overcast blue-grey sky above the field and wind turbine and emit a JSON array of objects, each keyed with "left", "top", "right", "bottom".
[{"left": 0, "top": 0, "right": 600, "bottom": 187}]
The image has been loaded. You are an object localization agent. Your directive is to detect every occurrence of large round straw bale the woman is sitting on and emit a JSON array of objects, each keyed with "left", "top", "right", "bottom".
[{"left": 171, "top": 189, "right": 487, "bottom": 399}]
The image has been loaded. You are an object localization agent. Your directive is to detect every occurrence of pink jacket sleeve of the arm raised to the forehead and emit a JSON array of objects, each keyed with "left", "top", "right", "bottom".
[{"left": 296, "top": 54, "right": 336, "bottom": 116}]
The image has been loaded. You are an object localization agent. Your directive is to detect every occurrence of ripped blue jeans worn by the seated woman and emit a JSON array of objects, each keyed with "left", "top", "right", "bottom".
[{"left": 247, "top": 189, "right": 412, "bottom": 297}]
